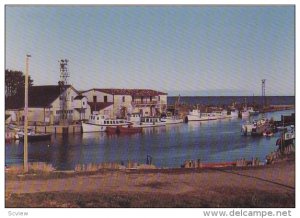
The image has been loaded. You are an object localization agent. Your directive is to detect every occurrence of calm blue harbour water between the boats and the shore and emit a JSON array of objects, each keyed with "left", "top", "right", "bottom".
[{"left": 5, "top": 110, "right": 294, "bottom": 169}]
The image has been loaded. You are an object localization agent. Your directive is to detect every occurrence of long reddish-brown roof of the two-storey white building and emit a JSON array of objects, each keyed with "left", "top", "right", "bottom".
[{"left": 84, "top": 89, "right": 167, "bottom": 97}]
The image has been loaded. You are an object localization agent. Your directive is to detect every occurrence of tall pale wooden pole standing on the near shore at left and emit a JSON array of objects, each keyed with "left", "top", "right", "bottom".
[{"left": 24, "top": 54, "right": 31, "bottom": 173}]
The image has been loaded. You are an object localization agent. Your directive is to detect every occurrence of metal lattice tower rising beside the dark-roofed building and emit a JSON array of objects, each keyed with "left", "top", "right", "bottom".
[{"left": 58, "top": 59, "right": 69, "bottom": 124}]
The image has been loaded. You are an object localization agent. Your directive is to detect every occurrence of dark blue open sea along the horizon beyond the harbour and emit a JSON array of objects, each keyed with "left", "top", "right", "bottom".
[{"left": 168, "top": 96, "right": 295, "bottom": 106}]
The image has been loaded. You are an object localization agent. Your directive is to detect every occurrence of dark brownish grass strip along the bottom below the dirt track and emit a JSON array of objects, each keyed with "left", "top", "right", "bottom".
[{"left": 5, "top": 188, "right": 295, "bottom": 208}]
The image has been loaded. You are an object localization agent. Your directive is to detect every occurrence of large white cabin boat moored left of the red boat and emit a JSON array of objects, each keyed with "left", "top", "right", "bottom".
[{"left": 82, "top": 114, "right": 131, "bottom": 132}]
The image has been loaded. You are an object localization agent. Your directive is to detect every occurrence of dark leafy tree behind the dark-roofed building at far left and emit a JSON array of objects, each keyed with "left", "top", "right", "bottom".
[{"left": 5, "top": 70, "right": 33, "bottom": 106}]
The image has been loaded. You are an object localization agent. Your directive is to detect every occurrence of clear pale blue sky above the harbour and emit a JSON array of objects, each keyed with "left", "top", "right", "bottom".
[{"left": 5, "top": 6, "right": 295, "bottom": 95}]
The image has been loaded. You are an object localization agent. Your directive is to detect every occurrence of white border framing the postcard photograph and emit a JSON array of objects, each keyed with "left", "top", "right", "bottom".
[{"left": 0, "top": 0, "right": 300, "bottom": 218}]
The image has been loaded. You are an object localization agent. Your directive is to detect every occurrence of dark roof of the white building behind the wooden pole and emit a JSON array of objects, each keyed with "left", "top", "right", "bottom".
[{"left": 6, "top": 85, "right": 77, "bottom": 109}]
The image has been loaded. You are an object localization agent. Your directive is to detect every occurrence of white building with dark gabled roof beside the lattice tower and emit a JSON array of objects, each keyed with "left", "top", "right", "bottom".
[{"left": 5, "top": 85, "right": 90, "bottom": 124}]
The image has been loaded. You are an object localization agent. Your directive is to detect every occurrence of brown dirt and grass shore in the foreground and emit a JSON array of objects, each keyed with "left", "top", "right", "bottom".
[{"left": 5, "top": 157, "right": 295, "bottom": 208}]
